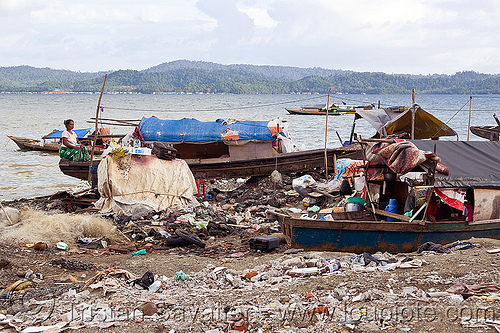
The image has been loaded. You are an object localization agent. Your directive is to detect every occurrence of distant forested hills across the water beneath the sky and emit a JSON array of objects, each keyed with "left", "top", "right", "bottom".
[{"left": 0, "top": 60, "right": 500, "bottom": 94}]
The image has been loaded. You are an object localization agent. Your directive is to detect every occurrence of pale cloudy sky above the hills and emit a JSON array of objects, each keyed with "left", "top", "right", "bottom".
[{"left": 0, "top": 0, "right": 500, "bottom": 75}]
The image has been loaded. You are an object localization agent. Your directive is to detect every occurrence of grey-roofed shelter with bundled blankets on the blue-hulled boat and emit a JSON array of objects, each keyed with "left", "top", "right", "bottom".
[{"left": 367, "top": 140, "right": 500, "bottom": 221}]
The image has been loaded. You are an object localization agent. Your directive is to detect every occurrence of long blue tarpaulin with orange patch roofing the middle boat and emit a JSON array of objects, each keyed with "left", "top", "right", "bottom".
[{"left": 139, "top": 117, "right": 274, "bottom": 142}]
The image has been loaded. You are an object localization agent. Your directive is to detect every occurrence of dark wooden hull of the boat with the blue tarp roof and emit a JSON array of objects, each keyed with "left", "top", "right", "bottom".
[{"left": 59, "top": 146, "right": 360, "bottom": 180}]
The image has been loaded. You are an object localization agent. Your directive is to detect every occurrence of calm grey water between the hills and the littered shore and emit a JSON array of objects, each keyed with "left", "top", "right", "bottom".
[{"left": 0, "top": 94, "right": 500, "bottom": 201}]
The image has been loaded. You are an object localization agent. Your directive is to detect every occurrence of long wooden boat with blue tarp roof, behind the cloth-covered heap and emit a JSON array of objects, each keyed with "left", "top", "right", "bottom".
[{"left": 59, "top": 117, "right": 366, "bottom": 179}]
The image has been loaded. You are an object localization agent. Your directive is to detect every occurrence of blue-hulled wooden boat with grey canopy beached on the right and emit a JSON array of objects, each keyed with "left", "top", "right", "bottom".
[{"left": 268, "top": 139, "right": 500, "bottom": 253}]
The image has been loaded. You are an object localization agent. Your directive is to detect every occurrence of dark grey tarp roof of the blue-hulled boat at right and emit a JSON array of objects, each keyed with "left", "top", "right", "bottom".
[{"left": 411, "top": 140, "right": 500, "bottom": 187}]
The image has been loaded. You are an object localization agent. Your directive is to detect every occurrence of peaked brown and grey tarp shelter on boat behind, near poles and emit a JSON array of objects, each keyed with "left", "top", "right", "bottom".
[{"left": 356, "top": 104, "right": 457, "bottom": 140}]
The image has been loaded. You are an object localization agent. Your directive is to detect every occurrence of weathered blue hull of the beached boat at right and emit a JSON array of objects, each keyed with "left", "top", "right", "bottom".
[{"left": 268, "top": 212, "right": 500, "bottom": 253}]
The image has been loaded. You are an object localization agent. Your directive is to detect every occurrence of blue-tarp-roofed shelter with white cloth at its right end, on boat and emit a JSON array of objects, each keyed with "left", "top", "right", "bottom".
[{"left": 138, "top": 117, "right": 293, "bottom": 160}]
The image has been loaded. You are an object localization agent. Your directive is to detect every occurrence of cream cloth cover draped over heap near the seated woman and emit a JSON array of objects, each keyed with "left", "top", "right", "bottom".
[{"left": 95, "top": 155, "right": 197, "bottom": 218}]
